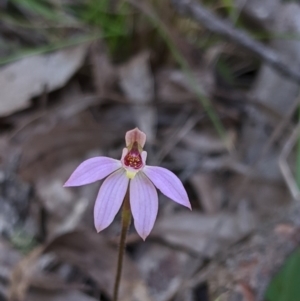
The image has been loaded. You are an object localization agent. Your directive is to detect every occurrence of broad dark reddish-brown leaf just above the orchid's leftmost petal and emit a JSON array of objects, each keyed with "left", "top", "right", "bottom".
[{"left": 21, "top": 118, "right": 110, "bottom": 179}]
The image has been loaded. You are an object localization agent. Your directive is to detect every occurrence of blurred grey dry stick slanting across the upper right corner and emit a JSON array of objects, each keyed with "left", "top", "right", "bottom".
[{"left": 172, "top": 0, "right": 300, "bottom": 83}]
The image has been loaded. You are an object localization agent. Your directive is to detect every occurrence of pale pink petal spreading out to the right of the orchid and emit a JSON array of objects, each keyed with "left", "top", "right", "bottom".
[{"left": 143, "top": 166, "right": 191, "bottom": 209}]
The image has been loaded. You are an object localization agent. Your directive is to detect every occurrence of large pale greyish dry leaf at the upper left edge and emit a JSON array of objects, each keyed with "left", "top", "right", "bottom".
[{"left": 0, "top": 44, "right": 88, "bottom": 116}]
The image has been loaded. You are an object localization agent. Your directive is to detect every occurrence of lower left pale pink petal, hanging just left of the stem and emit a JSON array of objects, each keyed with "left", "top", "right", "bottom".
[{"left": 94, "top": 168, "right": 129, "bottom": 232}]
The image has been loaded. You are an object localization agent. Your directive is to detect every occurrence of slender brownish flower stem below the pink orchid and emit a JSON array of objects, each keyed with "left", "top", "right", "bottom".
[{"left": 113, "top": 191, "right": 131, "bottom": 301}]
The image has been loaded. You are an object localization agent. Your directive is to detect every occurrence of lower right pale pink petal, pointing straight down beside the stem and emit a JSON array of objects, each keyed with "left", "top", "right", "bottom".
[{"left": 130, "top": 172, "right": 158, "bottom": 240}]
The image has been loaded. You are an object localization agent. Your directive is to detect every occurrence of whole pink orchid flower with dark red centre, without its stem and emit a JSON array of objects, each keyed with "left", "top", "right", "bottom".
[{"left": 64, "top": 128, "right": 191, "bottom": 240}]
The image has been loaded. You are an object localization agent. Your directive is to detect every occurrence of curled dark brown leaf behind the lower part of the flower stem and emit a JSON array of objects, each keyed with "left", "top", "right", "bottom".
[{"left": 46, "top": 231, "right": 151, "bottom": 301}]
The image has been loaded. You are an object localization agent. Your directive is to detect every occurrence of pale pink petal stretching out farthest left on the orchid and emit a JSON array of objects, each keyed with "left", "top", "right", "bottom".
[{"left": 64, "top": 157, "right": 122, "bottom": 187}]
